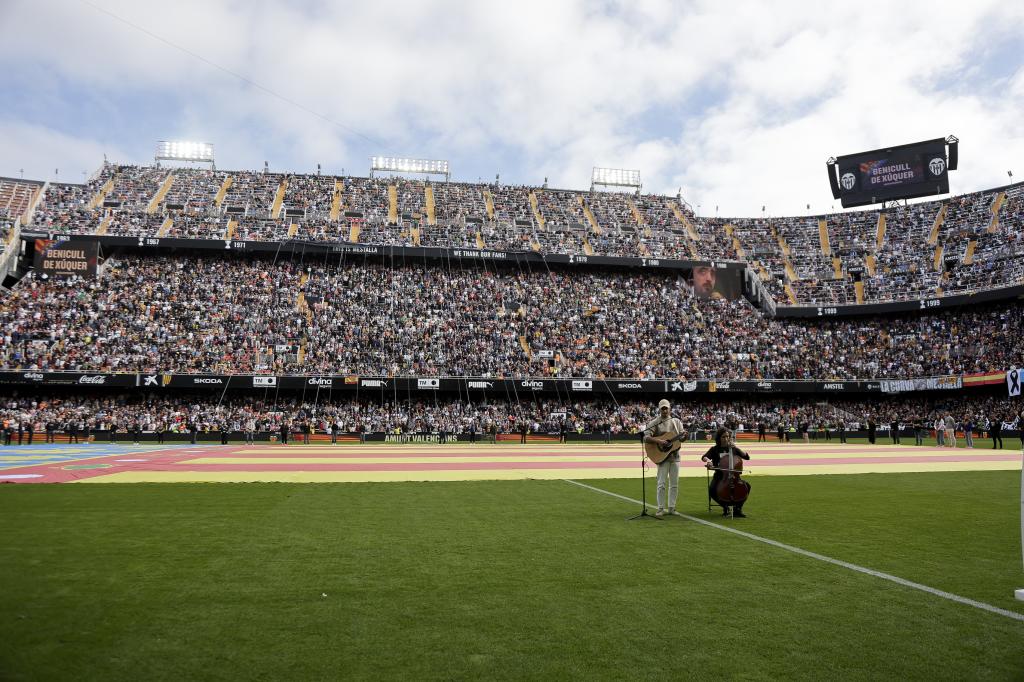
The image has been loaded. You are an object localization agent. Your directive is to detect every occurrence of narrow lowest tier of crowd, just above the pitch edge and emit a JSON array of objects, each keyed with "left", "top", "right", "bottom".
[{"left": 0, "top": 391, "right": 1024, "bottom": 437}]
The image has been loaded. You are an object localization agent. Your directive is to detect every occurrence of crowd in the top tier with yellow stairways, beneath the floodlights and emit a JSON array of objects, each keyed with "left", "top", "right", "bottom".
[{"left": 18, "top": 165, "right": 1024, "bottom": 304}]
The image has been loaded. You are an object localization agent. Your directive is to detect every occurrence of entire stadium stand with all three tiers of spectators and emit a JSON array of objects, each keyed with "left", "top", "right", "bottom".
[{"left": 0, "top": 158, "right": 1024, "bottom": 434}]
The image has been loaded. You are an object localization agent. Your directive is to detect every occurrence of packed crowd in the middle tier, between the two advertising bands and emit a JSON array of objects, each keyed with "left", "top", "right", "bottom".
[{"left": 0, "top": 250, "right": 1024, "bottom": 380}]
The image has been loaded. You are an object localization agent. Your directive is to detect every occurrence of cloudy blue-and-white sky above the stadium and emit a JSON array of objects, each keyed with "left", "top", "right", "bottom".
[{"left": 0, "top": 0, "right": 1024, "bottom": 216}]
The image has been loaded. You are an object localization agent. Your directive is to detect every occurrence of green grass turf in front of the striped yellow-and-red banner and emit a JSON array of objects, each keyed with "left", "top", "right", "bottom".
[{"left": 0, "top": 472, "right": 1024, "bottom": 680}]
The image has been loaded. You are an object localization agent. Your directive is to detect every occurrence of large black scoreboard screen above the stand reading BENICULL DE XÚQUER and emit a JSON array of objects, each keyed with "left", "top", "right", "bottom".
[{"left": 836, "top": 137, "right": 949, "bottom": 208}]
